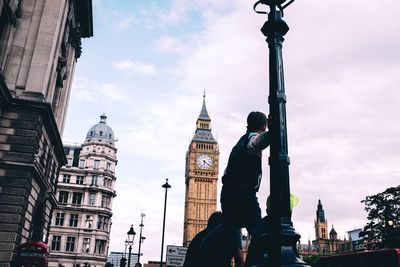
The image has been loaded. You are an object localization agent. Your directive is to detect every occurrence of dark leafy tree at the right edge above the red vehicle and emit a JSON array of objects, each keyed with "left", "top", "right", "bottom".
[{"left": 361, "top": 185, "right": 400, "bottom": 249}]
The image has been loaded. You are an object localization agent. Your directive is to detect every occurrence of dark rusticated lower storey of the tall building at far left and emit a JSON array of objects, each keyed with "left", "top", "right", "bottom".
[{"left": 0, "top": 88, "right": 66, "bottom": 266}]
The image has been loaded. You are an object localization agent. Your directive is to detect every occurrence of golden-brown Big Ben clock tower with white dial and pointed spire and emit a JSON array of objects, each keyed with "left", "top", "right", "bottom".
[{"left": 183, "top": 95, "right": 219, "bottom": 246}]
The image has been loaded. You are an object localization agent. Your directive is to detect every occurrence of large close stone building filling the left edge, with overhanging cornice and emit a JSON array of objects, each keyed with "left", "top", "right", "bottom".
[{"left": 0, "top": 0, "right": 93, "bottom": 266}]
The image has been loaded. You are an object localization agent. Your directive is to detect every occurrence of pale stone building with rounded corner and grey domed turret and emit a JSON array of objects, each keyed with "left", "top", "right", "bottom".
[{"left": 49, "top": 114, "right": 117, "bottom": 267}]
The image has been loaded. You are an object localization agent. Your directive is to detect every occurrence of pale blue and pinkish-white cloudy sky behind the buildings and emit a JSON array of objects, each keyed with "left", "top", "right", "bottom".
[{"left": 63, "top": 0, "right": 400, "bottom": 261}]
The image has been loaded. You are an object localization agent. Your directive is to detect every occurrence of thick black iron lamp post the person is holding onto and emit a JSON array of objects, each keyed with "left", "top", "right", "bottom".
[{"left": 254, "top": 0, "right": 308, "bottom": 267}]
